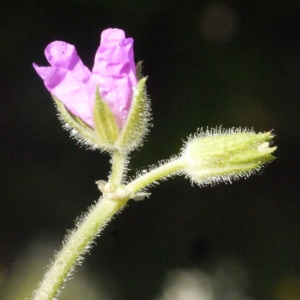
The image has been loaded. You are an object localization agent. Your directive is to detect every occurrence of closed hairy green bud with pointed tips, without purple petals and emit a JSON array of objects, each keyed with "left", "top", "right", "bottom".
[{"left": 182, "top": 128, "right": 276, "bottom": 186}]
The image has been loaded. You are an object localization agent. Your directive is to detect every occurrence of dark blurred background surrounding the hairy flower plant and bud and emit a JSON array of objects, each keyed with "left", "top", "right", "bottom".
[{"left": 0, "top": 0, "right": 300, "bottom": 300}]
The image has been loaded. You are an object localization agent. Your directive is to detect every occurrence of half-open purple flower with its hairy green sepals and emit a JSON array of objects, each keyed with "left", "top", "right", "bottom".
[{"left": 33, "top": 28, "right": 150, "bottom": 153}]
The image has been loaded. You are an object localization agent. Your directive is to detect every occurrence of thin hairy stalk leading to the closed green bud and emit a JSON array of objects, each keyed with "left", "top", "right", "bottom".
[{"left": 127, "top": 158, "right": 186, "bottom": 193}]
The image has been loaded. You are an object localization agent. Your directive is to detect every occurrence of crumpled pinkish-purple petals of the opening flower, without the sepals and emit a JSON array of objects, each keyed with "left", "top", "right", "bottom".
[{"left": 33, "top": 28, "right": 137, "bottom": 129}]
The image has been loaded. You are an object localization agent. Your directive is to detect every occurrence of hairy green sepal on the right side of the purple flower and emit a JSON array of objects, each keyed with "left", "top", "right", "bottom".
[{"left": 116, "top": 77, "right": 150, "bottom": 153}]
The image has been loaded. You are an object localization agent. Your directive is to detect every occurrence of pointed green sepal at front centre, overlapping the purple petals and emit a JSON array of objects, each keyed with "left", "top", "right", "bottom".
[{"left": 94, "top": 88, "right": 119, "bottom": 148}]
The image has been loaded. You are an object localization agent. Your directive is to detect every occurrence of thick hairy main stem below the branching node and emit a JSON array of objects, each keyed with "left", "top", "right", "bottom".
[{"left": 32, "top": 197, "right": 128, "bottom": 300}]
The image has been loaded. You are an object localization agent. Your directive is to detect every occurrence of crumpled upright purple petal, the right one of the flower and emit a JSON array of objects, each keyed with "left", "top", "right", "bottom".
[{"left": 90, "top": 29, "right": 137, "bottom": 127}]
